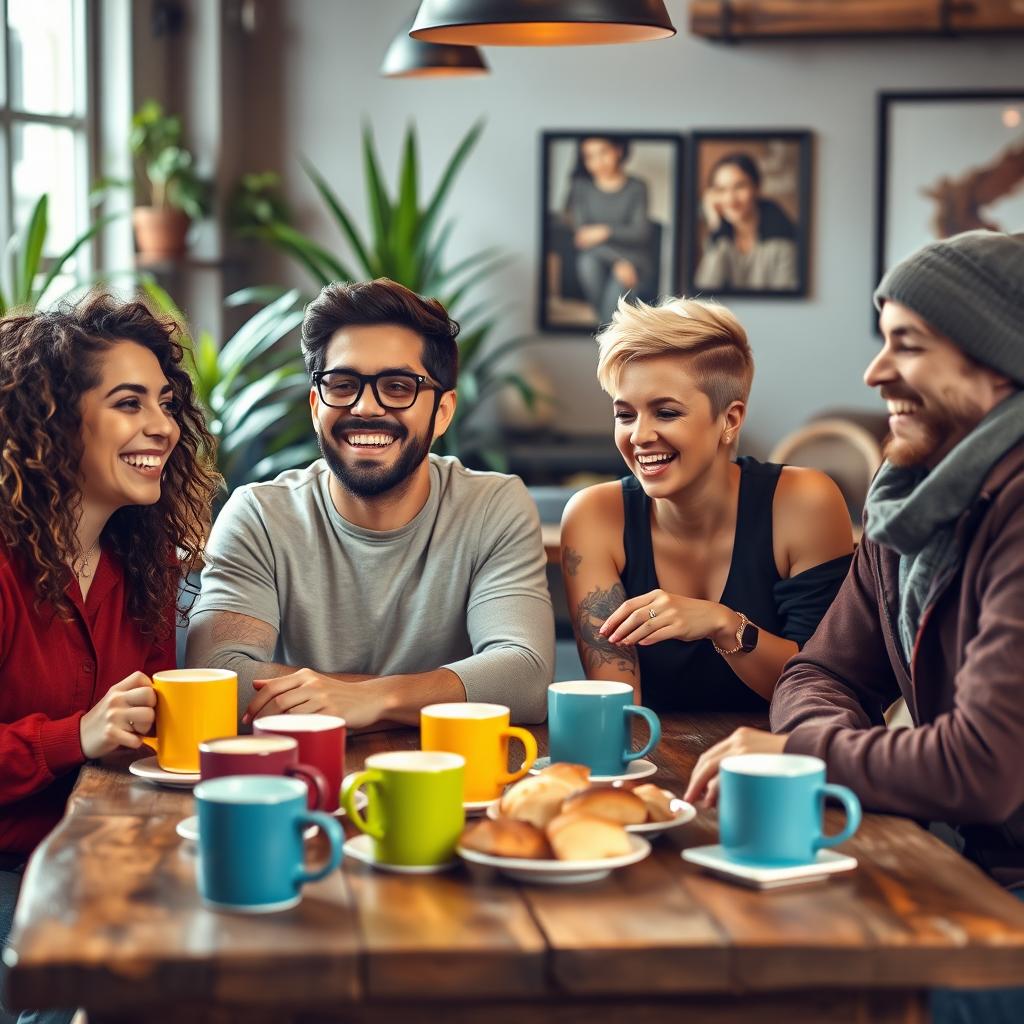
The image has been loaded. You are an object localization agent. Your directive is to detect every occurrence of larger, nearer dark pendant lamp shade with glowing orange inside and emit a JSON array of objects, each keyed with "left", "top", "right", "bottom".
[{"left": 411, "top": 0, "right": 676, "bottom": 46}]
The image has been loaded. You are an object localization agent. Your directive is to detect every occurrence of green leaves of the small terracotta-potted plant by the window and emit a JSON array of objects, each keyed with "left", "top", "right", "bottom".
[{"left": 131, "top": 99, "right": 210, "bottom": 220}]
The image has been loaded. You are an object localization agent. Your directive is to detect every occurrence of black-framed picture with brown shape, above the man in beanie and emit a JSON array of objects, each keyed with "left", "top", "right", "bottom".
[{"left": 874, "top": 91, "right": 1024, "bottom": 284}]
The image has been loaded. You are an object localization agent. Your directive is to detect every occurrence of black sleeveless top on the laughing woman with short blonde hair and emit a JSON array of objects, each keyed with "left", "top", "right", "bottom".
[{"left": 622, "top": 457, "right": 778, "bottom": 712}]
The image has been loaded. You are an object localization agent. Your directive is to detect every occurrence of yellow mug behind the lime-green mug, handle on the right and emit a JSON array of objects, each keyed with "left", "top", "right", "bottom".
[{"left": 420, "top": 701, "right": 537, "bottom": 803}]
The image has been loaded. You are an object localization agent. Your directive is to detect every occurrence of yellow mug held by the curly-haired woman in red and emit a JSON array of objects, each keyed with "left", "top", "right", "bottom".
[{"left": 142, "top": 669, "right": 239, "bottom": 772}]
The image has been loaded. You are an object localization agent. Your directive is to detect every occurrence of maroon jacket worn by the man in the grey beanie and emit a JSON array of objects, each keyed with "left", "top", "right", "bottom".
[{"left": 771, "top": 447, "right": 1024, "bottom": 885}]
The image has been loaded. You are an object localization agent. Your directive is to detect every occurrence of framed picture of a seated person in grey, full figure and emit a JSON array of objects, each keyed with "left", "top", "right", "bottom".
[{"left": 538, "top": 130, "right": 683, "bottom": 333}]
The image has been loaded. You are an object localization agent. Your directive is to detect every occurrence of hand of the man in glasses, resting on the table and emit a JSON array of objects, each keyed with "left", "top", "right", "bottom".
[{"left": 242, "top": 669, "right": 387, "bottom": 729}]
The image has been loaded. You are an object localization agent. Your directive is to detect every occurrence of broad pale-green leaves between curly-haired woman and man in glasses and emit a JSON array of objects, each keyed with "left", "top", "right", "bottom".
[{"left": 142, "top": 280, "right": 318, "bottom": 490}]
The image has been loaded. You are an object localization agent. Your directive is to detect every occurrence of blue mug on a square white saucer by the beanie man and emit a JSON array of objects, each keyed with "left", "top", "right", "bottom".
[{"left": 718, "top": 754, "right": 860, "bottom": 867}]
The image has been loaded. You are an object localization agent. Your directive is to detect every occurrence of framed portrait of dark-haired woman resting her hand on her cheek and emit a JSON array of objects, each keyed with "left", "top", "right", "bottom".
[{"left": 686, "top": 131, "right": 811, "bottom": 298}]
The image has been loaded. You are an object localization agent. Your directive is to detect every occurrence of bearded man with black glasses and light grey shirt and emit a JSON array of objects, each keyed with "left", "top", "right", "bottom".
[{"left": 186, "top": 279, "right": 554, "bottom": 728}]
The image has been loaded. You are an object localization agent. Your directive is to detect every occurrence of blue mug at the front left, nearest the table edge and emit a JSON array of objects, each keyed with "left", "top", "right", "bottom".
[{"left": 195, "top": 775, "right": 344, "bottom": 913}]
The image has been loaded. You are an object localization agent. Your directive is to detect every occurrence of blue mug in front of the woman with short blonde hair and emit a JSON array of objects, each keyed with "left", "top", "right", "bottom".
[{"left": 548, "top": 679, "right": 662, "bottom": 775}]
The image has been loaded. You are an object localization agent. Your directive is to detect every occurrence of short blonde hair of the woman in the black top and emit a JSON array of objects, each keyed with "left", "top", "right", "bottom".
[{"left": 597, "top": 298, "right": 754, "bottom": 417}]
